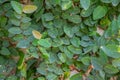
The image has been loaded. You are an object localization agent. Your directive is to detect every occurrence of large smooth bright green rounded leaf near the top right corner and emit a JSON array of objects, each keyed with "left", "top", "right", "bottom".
[{"left": 93, "top": 6, "right": 107, "bottom": 20}]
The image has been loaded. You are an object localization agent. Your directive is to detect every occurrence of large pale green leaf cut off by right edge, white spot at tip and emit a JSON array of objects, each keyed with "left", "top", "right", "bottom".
[{"left": 101, "top": 45, "right": 120, "bottom": 58}]
